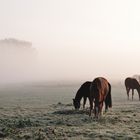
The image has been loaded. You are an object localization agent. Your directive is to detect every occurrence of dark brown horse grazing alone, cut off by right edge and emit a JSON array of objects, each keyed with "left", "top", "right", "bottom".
[{"left": 125, "top": 77, "right": 140, "bottom": 100}]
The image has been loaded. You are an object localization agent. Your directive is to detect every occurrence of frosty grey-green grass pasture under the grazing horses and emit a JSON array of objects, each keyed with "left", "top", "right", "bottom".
[{"left": 0, "top": 83, "right": 140, "bottom": 140}]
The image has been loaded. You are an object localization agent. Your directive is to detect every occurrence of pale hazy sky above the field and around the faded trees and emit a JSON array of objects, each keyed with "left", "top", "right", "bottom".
[{"left": 0, "top": 0, "right": 140, "bottom": 80}]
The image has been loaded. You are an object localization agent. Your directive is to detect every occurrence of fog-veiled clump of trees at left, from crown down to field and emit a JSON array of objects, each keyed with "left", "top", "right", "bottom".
[{"left": 0, "top": 38, "right": 38, "bottom": 84}]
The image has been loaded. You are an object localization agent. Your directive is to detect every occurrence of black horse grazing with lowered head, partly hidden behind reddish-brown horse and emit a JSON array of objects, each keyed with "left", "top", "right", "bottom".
[{"left": 73, "top": 81, "right": 91, "bottom": 109}]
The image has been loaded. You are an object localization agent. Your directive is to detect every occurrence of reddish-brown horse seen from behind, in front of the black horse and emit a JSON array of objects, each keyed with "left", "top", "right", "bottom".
[{"left": 89, "top": 77, "right": 112, "bottom": 118}]
